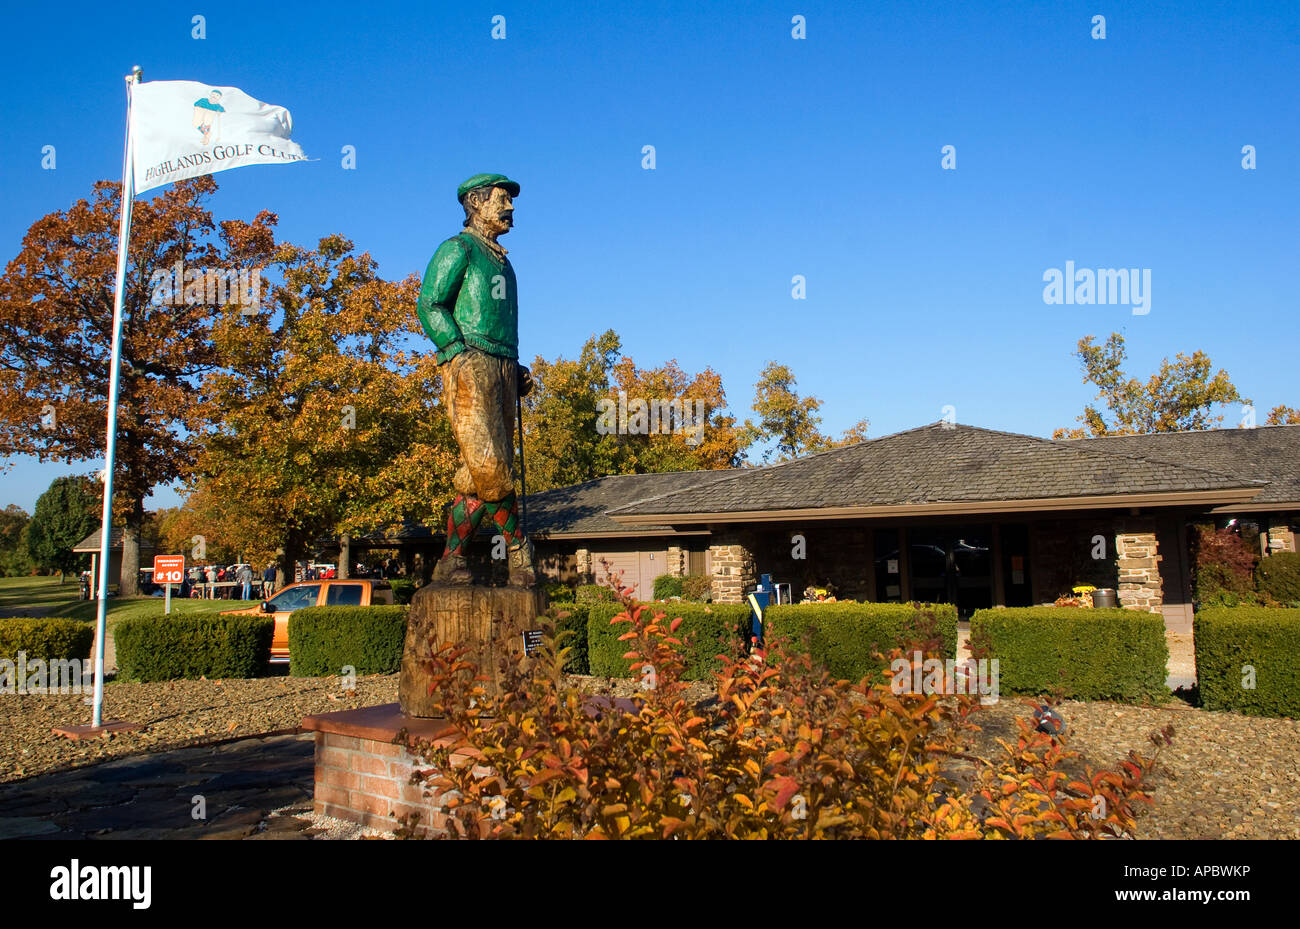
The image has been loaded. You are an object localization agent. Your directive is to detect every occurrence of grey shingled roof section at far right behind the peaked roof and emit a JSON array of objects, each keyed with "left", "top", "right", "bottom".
[{"left": 1074, "top": 426, "right": 1300, "bottom": 508}]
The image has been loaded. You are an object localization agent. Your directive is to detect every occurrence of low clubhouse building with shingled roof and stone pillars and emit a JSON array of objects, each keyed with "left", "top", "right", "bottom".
[{"left": 359, "top": 422, "right": 1300, "bottom": 631}]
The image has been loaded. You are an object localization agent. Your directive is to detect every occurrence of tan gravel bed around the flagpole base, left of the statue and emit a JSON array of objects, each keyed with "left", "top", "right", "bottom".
[{"left": 0, "top": 674, "right": 398, "bottom": 783}]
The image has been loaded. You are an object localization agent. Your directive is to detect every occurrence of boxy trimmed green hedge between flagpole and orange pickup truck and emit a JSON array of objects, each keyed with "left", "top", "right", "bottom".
[{"left": 113, "top": 615, "right": 276, "bottom": 681}]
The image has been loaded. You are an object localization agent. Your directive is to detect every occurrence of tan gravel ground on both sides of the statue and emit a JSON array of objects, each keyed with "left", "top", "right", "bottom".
[{"left": 0, "top": 674, "right": 1300, "bottom": 838}]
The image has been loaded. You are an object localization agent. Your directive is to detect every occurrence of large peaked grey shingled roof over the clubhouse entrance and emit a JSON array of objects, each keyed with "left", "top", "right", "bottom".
[{"left": 610, "top": 422, "right": 1264, "bottom": 526}]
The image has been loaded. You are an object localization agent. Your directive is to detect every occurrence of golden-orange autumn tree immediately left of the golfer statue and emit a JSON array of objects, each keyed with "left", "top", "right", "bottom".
[{"left": 185, "top": 235, "right": 444, "bottom": 578}]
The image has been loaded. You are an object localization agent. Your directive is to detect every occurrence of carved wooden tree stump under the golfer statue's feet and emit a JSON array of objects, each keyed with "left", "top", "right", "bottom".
[{"left": 398, "top": 583, "right": 546, "bottom": 719}]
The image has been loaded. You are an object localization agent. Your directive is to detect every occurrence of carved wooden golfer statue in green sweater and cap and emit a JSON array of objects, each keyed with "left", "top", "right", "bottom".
[{"left": 417, "top": 174, "right": 537, "bottom": 587}]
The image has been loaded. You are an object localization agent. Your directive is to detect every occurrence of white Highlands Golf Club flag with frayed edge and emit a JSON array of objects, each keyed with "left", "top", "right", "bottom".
[{"left": 131, "top": 81, "right": 307, "bottom": 194}]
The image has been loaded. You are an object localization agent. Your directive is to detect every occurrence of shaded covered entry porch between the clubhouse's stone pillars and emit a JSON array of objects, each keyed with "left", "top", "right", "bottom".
[{"left": 711, "top": 511, "right": 1192, "bottom": 631}]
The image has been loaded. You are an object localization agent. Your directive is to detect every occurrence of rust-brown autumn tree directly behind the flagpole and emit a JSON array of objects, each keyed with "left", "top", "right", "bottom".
[{"left": 0, "top": 177, "right": 274, "bottom": 595}]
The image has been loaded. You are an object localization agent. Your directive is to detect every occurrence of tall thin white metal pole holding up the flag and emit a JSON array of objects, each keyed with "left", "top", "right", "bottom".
[{"left": 91, "top": 65, "right": 142, "bottom": 726}]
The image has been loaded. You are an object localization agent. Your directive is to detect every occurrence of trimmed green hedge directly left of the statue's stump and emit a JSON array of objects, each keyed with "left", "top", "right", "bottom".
[{"left": 289, "top": 605, "right": 408, "bottom": 677}]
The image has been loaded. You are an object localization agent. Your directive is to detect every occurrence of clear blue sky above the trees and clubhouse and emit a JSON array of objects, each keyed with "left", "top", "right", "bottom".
[{"left": 0, "top": 0, "right": 1300, "bottom": 512}]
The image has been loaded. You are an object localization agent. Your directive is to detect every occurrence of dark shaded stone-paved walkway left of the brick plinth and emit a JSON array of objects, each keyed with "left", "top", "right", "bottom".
[{"left": 0, "top": 733, "right": 315, "bottom": 839}]
